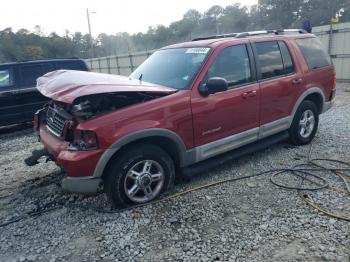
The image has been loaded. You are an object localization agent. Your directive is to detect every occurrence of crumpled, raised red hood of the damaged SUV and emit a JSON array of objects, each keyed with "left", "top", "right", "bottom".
[{"left": 37, "top": 70, "right": 177, "bottom": 104}]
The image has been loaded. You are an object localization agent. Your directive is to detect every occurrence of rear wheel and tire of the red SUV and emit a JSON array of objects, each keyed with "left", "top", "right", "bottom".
[{"left": 289, "top": 100, "right": 319, "bottom": 146}]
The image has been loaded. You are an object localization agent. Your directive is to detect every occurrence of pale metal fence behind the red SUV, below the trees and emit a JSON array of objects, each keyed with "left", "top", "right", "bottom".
[{"left": 85, "top": 23, "right": 350, "bottom": 82}]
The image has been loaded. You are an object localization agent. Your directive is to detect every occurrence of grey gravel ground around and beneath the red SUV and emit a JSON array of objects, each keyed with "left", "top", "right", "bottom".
[{"left": 0, "top": 85, "right": 350, "bottom": 262}]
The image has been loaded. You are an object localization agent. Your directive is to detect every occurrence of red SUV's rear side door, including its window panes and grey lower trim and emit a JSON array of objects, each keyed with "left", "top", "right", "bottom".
[{"left": 252, "top": 40, "right": 302, "bottom": 138}]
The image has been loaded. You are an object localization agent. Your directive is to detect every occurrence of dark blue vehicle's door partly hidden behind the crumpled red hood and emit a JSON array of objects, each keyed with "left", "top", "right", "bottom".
[{"left": 17, "top": 63, "right": 55, "bottom": 121}]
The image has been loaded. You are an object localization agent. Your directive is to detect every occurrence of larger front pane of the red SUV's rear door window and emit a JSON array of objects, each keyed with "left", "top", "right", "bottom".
[{"left": 256, "top": 41, "right": 284, "bottom": 79}]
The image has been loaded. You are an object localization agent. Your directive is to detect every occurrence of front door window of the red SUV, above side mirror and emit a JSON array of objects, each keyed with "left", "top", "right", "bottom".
[{"left": 206, "top": 45, "right": 252, "bottom": 87}]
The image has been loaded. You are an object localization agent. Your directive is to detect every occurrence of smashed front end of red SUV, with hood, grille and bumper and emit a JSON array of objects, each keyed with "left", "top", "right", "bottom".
[{"left": 25, "top": 70, "right": 177, "bottom": 194}]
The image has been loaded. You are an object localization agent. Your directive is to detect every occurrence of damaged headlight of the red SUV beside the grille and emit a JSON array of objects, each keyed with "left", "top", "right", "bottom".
[{"left": 70, "top": 129, "right": 98, "bottom": 151}]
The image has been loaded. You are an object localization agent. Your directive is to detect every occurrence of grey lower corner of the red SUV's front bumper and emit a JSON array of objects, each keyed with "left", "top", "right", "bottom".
[{"left": 62, "top": 177, "right": 102, "bottom": 195}]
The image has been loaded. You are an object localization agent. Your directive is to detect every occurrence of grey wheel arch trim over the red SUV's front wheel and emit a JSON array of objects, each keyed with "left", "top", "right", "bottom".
[{"left": 93, "top": 128, "right": 196, "bottom": 177}]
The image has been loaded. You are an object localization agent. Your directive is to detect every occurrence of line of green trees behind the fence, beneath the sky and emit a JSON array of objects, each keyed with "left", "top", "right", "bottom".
[{"left": 0, "top": 0, "right": 350, "bottom": 63}]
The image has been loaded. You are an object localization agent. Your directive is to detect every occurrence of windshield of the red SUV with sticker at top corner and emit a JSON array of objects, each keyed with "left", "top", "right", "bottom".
[{"left": 130, "top": 47, "right": 210, "bottom": 89}]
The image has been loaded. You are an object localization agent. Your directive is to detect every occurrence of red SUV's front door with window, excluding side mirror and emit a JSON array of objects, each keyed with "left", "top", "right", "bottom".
[{"left": 191, "top": 42, "right": 260, "bottom": 161}]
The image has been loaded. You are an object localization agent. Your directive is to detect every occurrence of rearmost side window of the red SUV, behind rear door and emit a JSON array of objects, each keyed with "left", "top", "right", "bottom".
[{"left": 296, "top": 37, "right": 331, "bottom": 69}]
